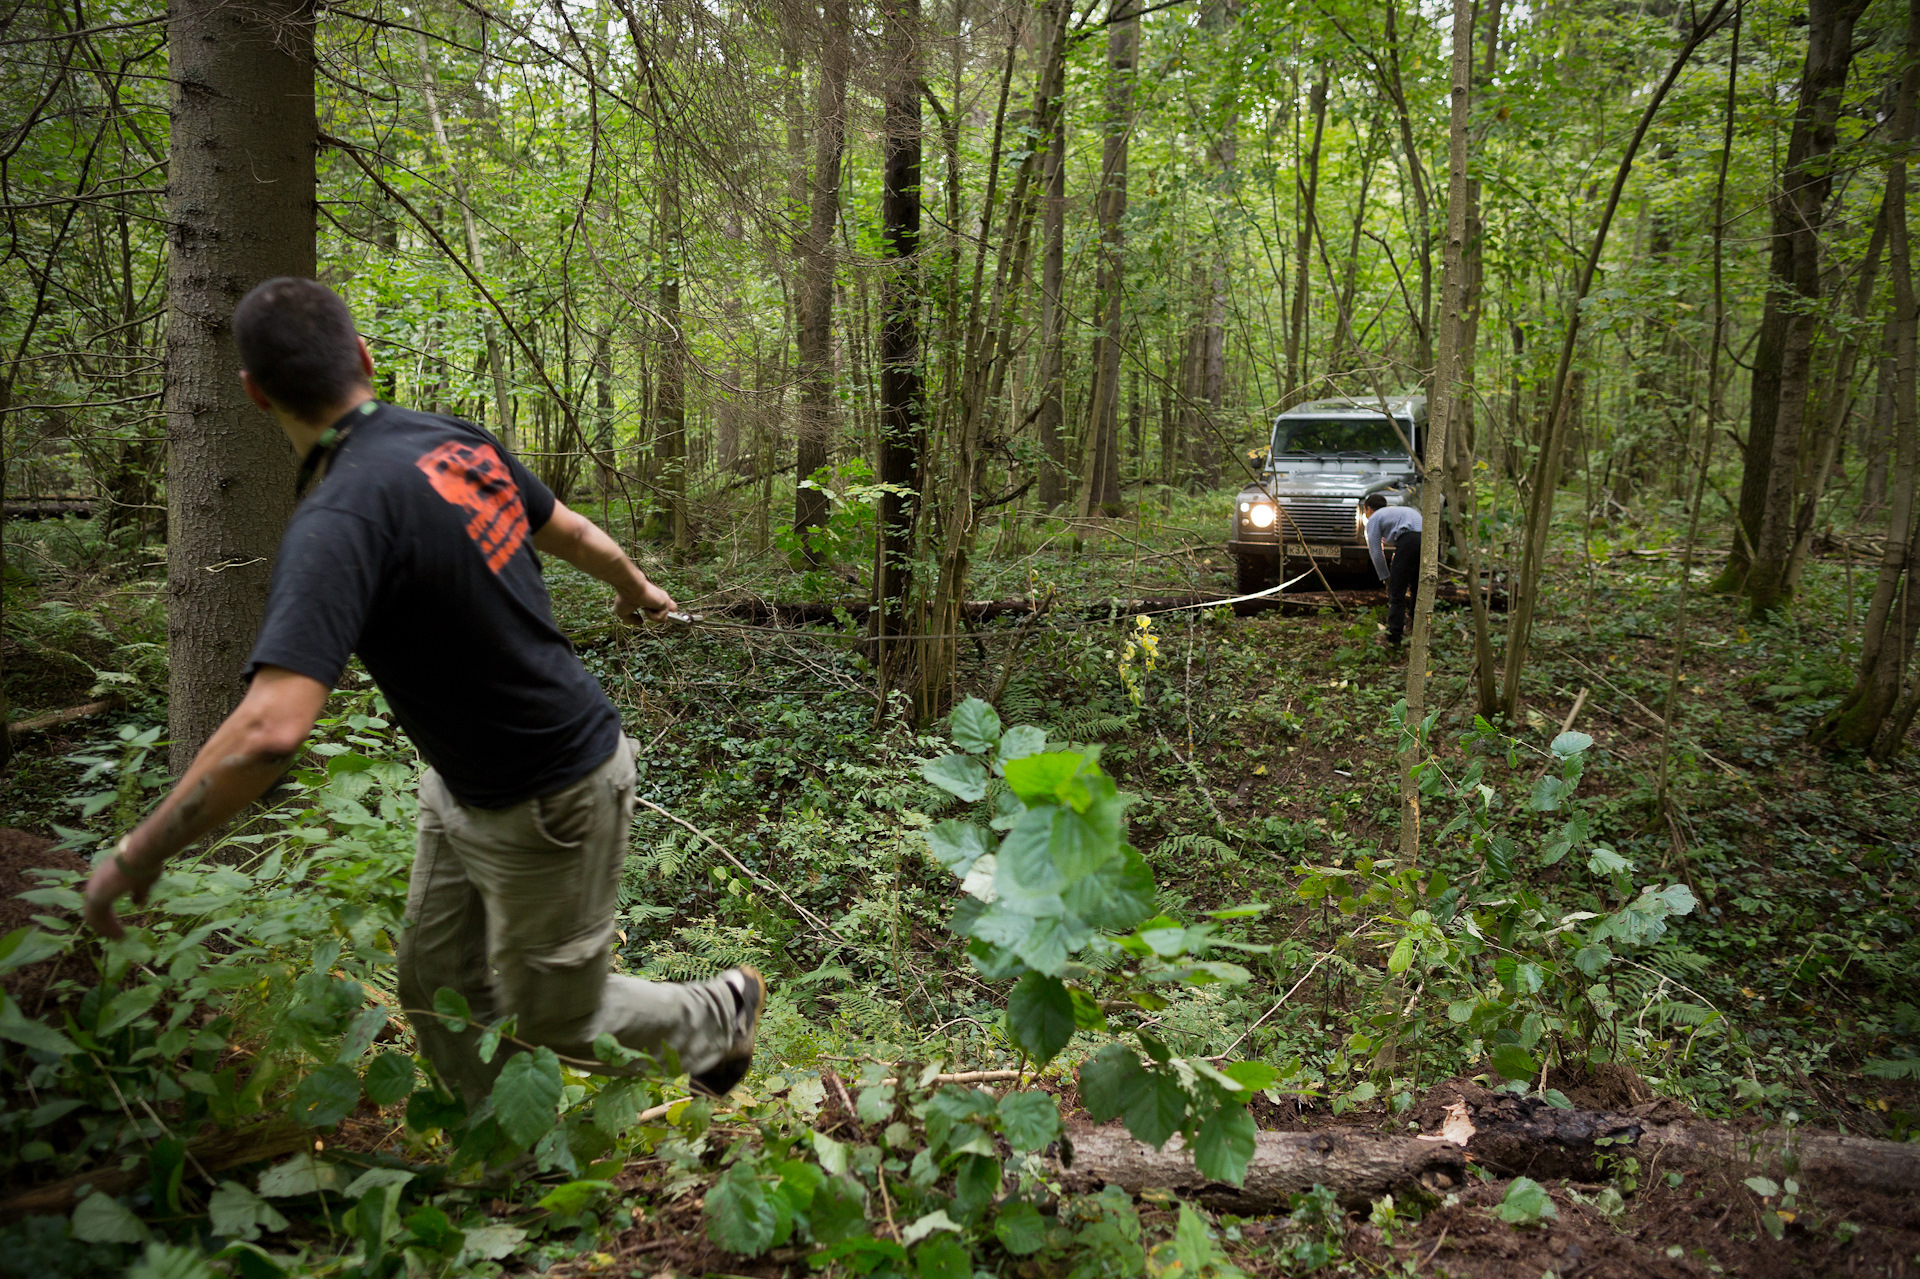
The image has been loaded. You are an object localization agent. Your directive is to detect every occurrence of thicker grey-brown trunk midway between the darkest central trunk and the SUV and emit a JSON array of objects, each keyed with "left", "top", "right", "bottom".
[{"left": 1081, "top": 0, "right": 1140, "bottom": 515}]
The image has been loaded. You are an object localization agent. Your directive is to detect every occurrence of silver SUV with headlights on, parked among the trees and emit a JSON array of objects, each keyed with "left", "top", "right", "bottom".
[{"left": 1227, "top": 396, "right": 1427, "bottom": 595}]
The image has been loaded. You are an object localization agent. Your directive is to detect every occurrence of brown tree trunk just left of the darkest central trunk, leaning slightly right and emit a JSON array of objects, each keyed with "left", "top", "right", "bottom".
[{"left": 793, "top": 0, "right": 852, "bottom": 563}]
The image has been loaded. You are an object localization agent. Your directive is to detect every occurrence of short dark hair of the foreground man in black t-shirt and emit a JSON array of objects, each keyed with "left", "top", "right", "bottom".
[{"left": 234, "top": 275, "right": 367, "bottom": 417}]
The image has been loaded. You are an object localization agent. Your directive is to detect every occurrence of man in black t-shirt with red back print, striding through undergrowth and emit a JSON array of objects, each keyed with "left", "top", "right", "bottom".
[{"left": 86, "top": 278, "right": 766, "bottom": 1102}]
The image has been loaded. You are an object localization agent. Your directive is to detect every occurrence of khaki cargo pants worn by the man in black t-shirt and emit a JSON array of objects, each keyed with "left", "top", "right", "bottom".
[{"left": 397, "top": 739, "right": 733, "bottom": 1104}]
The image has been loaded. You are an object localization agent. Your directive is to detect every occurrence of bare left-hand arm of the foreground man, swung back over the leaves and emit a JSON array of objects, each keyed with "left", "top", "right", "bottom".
[{"left": 86, "top": 666, "right": 328, "bottom": 937}]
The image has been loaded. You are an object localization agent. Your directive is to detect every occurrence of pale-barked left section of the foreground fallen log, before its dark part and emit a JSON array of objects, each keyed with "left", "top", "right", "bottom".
[{"left": 1056, "top": 1127, "right": 1467, "bottom": 1216}]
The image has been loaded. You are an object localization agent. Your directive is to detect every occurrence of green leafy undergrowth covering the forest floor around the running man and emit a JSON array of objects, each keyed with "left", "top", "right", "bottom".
[{"left": 0, "top": 491, "right": 1920, "bottom": 1279}]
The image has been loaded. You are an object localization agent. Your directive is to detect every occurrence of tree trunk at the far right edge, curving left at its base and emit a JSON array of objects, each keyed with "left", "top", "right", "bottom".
[{"left": 1812, "top": 4, "right": 1920, "bottom": 759}]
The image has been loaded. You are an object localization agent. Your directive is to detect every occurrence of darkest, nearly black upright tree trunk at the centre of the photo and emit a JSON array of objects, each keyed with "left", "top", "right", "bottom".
[{"left": 874, "top": 0, "right": 925, "bottom": 641}]
